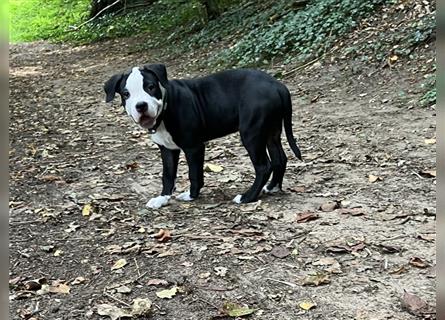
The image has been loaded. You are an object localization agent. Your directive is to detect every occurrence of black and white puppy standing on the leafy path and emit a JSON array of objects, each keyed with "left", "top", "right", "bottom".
[{"left": 104, "top": 64, "right": 301, "bottom": 208}]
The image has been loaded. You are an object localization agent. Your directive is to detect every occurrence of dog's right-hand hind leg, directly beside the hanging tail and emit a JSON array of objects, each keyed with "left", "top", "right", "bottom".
[{"left": 263, "top": 130, "right": 287, "bottom": 193}]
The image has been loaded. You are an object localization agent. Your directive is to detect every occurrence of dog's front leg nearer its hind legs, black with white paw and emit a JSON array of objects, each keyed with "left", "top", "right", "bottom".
[{"left": 176, "top": 144, "right": 205, "bottom": 201}]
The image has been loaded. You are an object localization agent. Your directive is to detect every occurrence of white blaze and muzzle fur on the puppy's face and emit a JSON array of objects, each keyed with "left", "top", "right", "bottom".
[{"left": 125, "top": 67, "right": 162, "bottom": 123}]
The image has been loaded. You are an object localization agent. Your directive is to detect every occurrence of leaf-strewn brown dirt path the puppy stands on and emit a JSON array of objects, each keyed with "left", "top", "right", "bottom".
[{"left": 10, "top": 41, "right": 436, "bottom": 320}]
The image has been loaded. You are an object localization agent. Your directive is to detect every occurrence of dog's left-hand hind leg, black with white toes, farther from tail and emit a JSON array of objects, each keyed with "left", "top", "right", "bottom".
[{"left": 233, "top": 133, "right": 272, "bottom": 203}]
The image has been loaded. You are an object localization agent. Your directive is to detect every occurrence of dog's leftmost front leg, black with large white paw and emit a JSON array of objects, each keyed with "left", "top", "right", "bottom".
[{"left": 147, "top": 145, "right": 181, "bottom": 209}]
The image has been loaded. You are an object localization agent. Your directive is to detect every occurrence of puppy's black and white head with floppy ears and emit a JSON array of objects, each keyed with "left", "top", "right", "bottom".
[{"left": 104, "top": 64, "right": 168, "bottom": 129}]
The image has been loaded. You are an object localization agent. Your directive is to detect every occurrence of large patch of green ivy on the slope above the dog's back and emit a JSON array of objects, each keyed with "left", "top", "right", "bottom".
[{"left": 213, "top": 0, "right": 390, "bottom": 66}]
